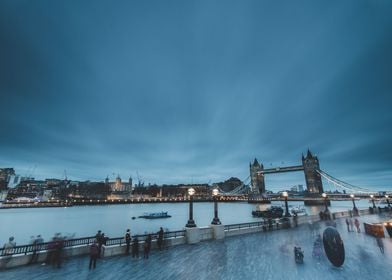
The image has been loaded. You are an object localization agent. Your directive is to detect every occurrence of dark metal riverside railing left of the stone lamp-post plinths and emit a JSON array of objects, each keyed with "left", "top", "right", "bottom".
[{"left": 0, "top": 230, "right": 185, "bottom": 257}]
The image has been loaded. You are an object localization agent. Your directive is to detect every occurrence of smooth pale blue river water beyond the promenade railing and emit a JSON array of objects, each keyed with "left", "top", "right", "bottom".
[{"left": 0, "top": 200, "right": 370, "bottom": 246}]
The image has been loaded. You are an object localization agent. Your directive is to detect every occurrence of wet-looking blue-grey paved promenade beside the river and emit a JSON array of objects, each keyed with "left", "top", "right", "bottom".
[{"left": 0, "top": 213, "right": 392, "bottom": 280}]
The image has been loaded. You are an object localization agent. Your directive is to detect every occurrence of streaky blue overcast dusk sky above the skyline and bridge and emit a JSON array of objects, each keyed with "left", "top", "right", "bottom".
[{"left": 0, "top": 0, "right": 392, "bottom": 190}]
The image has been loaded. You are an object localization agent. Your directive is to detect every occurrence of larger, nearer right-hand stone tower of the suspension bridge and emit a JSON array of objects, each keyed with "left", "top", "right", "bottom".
[{"left": 302, "top": 149, "right": 324, "bottom": 194}]
